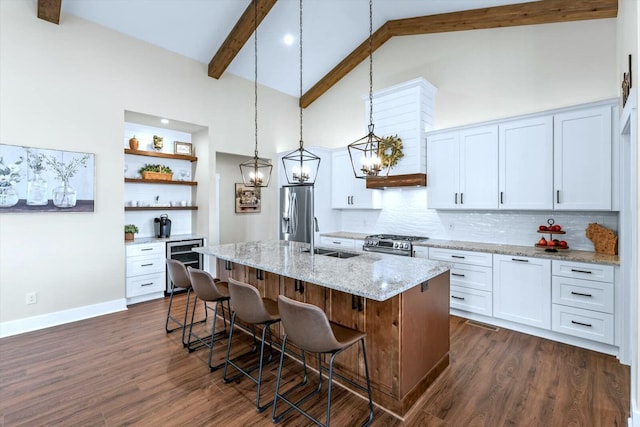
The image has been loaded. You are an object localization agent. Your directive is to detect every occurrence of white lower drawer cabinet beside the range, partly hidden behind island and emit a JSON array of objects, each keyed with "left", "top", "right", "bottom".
[{"left": 429, "top": 248, "right": 493, "bottom": 316}]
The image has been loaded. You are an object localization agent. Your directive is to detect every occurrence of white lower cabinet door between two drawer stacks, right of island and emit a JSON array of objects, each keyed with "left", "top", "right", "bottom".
[{"left": 493, "top": 255, "right": 551, "bottom": 329}]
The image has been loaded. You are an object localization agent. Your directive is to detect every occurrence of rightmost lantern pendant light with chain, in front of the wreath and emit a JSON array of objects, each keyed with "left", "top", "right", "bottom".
[{"left": 347, "top": 0, "right": 392, "bottom": 179}]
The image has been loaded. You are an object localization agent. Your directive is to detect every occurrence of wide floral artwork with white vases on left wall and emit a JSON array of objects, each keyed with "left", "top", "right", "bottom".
[{"left": 0, "top": 144, "right": 95, "bottom": 214}]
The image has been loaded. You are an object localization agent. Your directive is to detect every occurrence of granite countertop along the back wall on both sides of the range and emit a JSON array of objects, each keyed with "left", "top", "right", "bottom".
[{"left": 321, "top": 231, "right": 620, "bottom": 265}]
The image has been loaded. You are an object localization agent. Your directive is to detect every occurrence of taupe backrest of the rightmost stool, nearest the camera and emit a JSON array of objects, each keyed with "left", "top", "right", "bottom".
[{"left": 278, "top": 295, "right": 343, "bottom": 353}]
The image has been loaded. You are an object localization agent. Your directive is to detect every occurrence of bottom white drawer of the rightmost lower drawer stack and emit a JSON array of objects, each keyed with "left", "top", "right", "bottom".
[{"left": 551, "top": 304, "right": 614, "bottom": 344}]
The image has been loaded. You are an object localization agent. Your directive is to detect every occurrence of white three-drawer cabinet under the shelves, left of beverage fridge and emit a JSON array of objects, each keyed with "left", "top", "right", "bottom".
[{"left": 126, "top": 242, "right": 166, "bottom": 304}]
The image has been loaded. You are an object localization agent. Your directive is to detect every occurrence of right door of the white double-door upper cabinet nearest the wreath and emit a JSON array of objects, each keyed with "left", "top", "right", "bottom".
[{"left": 459, "top": 125, "right": 498, "bottom": 209}]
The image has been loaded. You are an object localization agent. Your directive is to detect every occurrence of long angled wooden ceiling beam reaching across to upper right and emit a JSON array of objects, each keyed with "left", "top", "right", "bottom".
[{"left": 299, "top": 0, "right": 618, "bottom": 108}]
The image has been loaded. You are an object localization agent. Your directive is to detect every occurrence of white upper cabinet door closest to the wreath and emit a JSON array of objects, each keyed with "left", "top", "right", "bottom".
[{"left": 427, "top": 131, "right": 460, "bottom": 209}]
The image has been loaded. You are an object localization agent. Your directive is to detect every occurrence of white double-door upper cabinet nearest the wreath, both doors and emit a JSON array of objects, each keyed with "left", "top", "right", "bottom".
[{"left": 427, "top": 125, "right": 498, "bottom": 209}]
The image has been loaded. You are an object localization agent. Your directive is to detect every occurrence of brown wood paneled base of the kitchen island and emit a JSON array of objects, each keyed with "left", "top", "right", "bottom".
[{"left": 214, "top": 251, "right": 449, "bottom": 418}]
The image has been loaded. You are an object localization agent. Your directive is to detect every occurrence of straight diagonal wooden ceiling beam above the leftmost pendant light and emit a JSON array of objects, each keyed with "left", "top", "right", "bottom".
[{"left": 210, "top": 0, "right": 277, "bottom": 79}]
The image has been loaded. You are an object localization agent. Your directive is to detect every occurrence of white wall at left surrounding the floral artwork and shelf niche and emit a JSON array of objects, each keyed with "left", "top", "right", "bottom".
[{"left": 0, "top": 0, "right": 298, "bottom": 328}]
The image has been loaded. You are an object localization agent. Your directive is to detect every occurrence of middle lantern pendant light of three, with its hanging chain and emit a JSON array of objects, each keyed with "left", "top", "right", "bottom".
[{"left": 282, "top": 0, "right": 320, "bottom": 185}]
